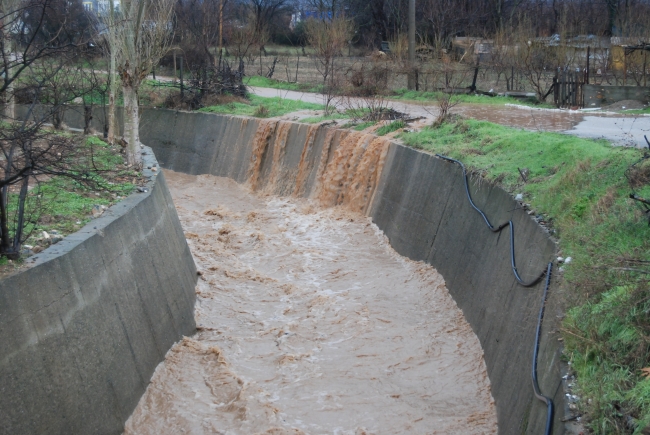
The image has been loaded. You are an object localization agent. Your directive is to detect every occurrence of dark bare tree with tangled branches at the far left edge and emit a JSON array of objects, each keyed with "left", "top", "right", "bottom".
[{"left": 0, "top": 0, "right": 110, "bottom": 258}]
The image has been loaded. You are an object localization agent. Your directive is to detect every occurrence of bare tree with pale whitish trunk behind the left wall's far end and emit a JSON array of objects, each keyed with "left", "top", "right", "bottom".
[{"left": 112, "top": 0, "right": 174, "bottom": 166}]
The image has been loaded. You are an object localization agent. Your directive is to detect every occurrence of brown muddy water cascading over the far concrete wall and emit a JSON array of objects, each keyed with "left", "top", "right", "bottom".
[{"left": 243, "top": 120, "right": 389, "bottom": 214}]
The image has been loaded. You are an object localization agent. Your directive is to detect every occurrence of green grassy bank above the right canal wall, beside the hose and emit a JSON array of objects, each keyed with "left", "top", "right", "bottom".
[{"left": 399, "top": 120, "right": 650, "bottom": 433}]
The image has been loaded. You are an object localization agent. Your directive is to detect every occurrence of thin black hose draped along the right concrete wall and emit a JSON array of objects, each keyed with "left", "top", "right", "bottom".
[{"left": 436, "top": 154, "right": 553, "bottom": 435}]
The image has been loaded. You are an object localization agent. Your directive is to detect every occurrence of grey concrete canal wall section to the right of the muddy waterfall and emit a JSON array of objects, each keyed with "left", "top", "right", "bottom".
[{"left": 372, "top": 145, "right": 563, "bottom": 434}]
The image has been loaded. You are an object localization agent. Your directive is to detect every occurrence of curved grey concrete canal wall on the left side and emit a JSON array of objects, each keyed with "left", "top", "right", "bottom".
[{"left": 0, "top": 150, "right": 196, "bottom": 435}]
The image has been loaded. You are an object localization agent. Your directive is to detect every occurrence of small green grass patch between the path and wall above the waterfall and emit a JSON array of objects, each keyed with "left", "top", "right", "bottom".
[{"left": 199, "top": 95, "right": 325, "bottom": 118}]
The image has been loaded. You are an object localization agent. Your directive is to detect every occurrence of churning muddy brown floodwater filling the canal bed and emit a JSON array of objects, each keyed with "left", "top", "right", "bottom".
[{"left": 125, "top": 171, "right": 497, "bottom": 435}]
